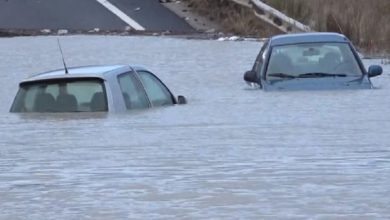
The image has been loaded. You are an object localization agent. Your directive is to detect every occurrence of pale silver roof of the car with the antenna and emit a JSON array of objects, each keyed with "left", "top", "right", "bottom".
[{"left": 22, "top": 64, "right": 150, "bottom": 83}]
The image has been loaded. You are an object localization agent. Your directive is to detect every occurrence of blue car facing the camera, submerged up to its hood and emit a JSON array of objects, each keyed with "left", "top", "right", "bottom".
[{"left": 244, "top": 33, "right": 383, "bottom": 90}]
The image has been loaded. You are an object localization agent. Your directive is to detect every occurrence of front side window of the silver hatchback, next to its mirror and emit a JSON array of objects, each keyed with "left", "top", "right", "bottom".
[{"left": 137, "top": 71, "right": 174, "bottom": 106}]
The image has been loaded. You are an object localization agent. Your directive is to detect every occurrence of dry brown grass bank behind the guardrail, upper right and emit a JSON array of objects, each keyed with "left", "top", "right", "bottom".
[{"left": 264, "top": 0, "right": 390, "bottom": 52}]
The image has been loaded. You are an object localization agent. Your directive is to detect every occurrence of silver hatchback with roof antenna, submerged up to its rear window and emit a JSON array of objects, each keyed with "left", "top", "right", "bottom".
[{"left": 10, "top": 65, "right": 186, "bottom": 112}]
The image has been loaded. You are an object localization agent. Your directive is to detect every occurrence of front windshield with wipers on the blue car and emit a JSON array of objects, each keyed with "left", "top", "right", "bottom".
[{"left": 266, "top": 42, "right": 363, "bottom": 80}]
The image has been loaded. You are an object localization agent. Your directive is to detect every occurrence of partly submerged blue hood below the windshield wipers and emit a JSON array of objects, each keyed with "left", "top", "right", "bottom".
[{"left": 264, "top": 77, "right": 372, "bottom": 91}]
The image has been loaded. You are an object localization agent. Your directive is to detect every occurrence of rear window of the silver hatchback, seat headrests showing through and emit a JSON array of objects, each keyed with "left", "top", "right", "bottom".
[{"left": 11, "top": 79, "right": 107, "bottom": 112}]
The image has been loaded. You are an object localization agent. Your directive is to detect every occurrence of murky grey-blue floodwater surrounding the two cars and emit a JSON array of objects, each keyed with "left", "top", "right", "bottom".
[{"left": 0, "top": 36, "right": 390, "bottom": 220}]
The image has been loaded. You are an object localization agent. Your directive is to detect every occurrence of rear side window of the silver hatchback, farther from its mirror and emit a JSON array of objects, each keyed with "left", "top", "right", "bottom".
[{"left": 118, "top": 73, "right": 149, "bottom": 109}]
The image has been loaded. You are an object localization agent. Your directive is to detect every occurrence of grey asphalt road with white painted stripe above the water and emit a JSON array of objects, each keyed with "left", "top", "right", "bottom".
[{"left": 0, "top": 0, "right": 193, "bottom": 32}]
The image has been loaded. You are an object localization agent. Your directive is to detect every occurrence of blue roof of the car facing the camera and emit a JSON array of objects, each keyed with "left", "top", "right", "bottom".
[{"left": 270, "top": 32, "right": 350, "bottom": 46}]
